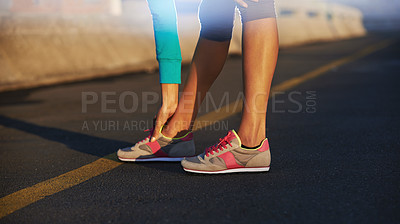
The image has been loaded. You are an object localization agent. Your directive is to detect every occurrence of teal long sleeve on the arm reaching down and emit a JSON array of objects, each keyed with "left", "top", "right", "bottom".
[{"left": 147, "top": 0, "right": 182, "bottom": 84}]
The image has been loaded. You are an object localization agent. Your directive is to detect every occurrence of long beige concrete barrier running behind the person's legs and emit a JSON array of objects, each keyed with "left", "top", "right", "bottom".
[{"left": 0, "top": 0, "right": 366, "bottom": 91}]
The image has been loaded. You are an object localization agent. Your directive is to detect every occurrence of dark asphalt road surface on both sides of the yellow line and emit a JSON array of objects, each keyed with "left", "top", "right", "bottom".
[{"left": 0, "top": 33, "right": 400, "bottom": 223}]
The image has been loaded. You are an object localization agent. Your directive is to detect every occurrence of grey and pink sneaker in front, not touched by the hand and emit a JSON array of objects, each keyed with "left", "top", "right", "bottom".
[{"left": 182, "top": 130, "right": 271, "bottom": 174}]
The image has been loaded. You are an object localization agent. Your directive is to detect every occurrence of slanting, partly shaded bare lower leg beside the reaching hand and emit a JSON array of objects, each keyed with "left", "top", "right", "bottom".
[{"left": 162, "top": 38, "right": 230, "bottom": 137}]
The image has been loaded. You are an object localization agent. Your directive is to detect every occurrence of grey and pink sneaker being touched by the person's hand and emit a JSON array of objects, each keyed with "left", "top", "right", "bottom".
[{"left": 117, "top": 130, "right": 196, "bottom": 162}]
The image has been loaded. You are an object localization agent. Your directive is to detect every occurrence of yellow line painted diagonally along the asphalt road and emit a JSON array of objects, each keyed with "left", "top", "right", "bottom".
[{"left": 0, "top": 40, "right": 395, "bottom": 218}]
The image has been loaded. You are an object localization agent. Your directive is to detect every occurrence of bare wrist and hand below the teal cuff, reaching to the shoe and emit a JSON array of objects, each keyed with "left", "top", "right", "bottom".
[{"left": 150, "top": 84, "right": 179, "bottom": 142}]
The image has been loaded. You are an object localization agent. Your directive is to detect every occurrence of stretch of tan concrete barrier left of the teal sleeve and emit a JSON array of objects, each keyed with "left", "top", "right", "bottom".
[{"left": 0, "top": 13, "right": 156, "bottom": 90}]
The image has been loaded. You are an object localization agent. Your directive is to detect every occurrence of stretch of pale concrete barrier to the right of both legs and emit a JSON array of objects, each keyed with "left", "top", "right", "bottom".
[{"left": 276, "top": 0, "right": 366, "bottom": 47}]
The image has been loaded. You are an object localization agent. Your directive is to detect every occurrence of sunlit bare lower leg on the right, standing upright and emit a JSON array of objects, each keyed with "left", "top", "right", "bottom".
[{"left": 238, "top": 18, "right": 279, "bottom": 147}]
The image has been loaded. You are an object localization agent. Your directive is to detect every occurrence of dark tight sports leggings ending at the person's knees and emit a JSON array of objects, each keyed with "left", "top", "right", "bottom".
[{"left": 199, "top": 0, "right": 276, "bottom": 41}]
